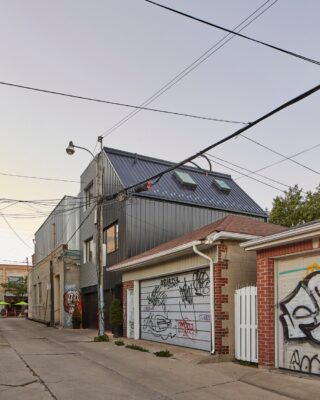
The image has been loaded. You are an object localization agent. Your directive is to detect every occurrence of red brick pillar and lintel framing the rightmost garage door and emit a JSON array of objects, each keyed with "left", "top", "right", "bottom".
[{"left": 257, "top": 240, "right": 312, "bottom": 367}]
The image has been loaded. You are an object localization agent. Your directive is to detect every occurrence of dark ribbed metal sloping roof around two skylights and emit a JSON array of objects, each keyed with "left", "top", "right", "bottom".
[{"left": 104, "top": 147, "right": 267, "bottom": 217}]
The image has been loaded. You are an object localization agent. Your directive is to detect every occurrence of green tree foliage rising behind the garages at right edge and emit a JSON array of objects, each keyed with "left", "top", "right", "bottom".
[{"left": 269, "top": 185, "right": 320, "bottom": 228}]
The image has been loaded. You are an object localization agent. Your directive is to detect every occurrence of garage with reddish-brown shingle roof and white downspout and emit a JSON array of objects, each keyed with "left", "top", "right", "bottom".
[{"left": 111, "top": 215, "right": 284, "bottom": 359}]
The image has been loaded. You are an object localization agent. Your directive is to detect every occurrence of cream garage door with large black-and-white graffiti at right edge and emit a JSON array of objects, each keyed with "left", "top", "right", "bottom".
[{"left": 278, "top": 256, "right": 320, "bottom": 374}]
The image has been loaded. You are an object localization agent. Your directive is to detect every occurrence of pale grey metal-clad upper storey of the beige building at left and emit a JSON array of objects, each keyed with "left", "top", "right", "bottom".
[{"left": 35, "top": 196, "right": 80, "bottom": 263}]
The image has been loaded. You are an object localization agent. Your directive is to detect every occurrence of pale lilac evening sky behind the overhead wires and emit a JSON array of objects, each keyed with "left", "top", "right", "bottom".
[{"left": 0, "top": 0, "right": 320, "bottom": 262}]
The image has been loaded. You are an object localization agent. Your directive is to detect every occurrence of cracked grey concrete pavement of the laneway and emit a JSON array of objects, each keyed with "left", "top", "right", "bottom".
[{"left": 0, "top": 318, "right": 320, "bottom": 400}]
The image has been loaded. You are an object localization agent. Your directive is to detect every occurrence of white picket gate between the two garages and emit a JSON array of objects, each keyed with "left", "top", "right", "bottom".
[{"left": 234, "top": 286, "right": 258, "bottom": 362}]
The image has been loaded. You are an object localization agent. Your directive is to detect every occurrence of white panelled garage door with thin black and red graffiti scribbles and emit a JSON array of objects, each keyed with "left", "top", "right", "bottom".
[{"left": 140, "top": 269, "right": 211, "bottom": 351}]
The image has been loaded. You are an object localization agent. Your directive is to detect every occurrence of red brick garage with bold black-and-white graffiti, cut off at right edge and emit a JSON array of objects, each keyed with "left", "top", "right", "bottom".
[{"left": 243, "top": 221, "right": 320, "bottom": 374}]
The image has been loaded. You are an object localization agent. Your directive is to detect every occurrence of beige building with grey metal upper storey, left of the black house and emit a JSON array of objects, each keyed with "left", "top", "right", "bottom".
[{"left": 28, "top": 196, "right": 81, "bottom": 328}]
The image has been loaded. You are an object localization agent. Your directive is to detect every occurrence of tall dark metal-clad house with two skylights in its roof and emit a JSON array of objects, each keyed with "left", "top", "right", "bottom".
[{"left": 80, "top": 148, "right": 267, "bottom": 329}]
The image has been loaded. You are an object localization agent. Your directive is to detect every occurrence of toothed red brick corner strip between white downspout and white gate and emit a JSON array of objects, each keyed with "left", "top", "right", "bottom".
[{"left": 214, "top": 244, "right": 229, "bottom": 354}]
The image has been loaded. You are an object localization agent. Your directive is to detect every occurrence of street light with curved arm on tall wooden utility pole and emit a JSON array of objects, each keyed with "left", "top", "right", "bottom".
[{"left": 66, "top": 136, "right": 104, "bottom": 336}]
